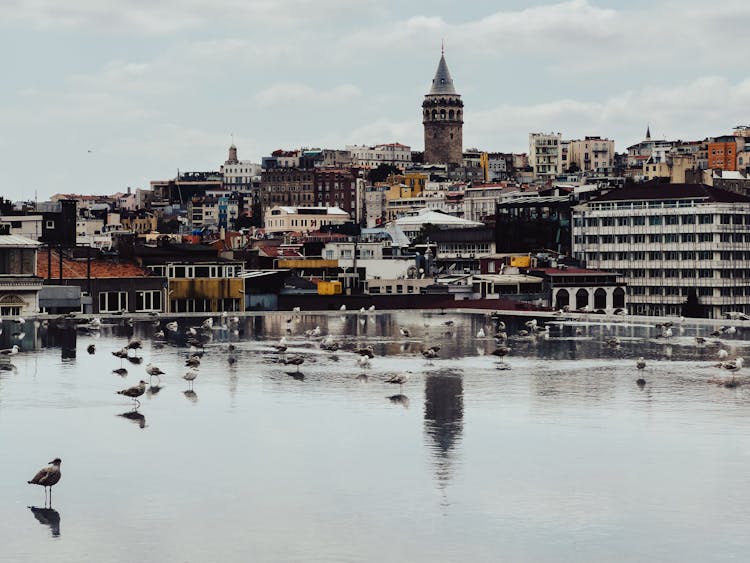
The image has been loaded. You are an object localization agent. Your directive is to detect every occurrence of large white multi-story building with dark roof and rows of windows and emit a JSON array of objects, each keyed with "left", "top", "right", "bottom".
[{"left": 573, "top": 184, "right": 750, "bottom": 318}]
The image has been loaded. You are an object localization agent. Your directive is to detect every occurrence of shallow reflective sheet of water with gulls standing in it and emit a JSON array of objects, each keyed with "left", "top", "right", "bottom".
[{"left": 0, "top": 312, "right": 750, "bottom": 562}]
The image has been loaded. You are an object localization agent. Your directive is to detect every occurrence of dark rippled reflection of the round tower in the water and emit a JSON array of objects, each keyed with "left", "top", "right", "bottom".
[{"left": 424, "top": 373, "right": 464, "bottom": 488}]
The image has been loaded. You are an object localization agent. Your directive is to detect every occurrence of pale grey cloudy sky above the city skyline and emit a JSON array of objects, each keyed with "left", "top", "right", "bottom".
[{"left": 0, "top": 0, "right": 750, "bottom": 200}]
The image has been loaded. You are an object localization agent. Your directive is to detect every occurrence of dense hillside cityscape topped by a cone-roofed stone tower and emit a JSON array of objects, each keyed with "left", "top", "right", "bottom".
[{"left": 0, "top": 52, "right": 750, "bottom": 318}]
